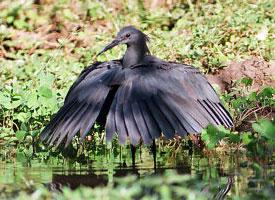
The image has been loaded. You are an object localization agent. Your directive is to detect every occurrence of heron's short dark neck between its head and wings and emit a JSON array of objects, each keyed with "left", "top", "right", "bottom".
[{"left": 122, "top": 43, "right": 150, "bottom": 68}]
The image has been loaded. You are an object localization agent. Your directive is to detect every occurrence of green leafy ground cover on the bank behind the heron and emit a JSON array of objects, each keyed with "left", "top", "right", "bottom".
[{"left": 0, "top": 0, "right": 275, "bottom": 199}]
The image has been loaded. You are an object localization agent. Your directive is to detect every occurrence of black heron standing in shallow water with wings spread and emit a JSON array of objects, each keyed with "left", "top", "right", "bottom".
[{"left": 41, "top": 26, "right": 233, "bottom": 164}]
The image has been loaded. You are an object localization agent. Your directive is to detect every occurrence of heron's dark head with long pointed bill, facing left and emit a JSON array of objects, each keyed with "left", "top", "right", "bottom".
[{"left": 97, "top": 26, "right": 149, "bottom": 55}]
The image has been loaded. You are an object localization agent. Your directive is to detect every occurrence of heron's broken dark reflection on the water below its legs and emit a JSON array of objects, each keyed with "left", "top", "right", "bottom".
[{"left": 47, "top": 166, "right": 234, "bottom": 200}]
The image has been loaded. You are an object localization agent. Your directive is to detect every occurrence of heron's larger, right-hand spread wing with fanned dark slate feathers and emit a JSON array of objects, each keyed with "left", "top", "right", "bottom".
[{"left": 106, "top": 61, "right": 233, "bottom": 145}]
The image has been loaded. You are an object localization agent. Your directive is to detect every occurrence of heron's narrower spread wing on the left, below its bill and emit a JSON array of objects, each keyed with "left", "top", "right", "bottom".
[{"left": 41, "top": 61, "right": 123, "bottom": 146}]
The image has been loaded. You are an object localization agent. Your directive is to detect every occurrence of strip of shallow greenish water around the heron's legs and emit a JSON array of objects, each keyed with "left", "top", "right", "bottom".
[{"left": 0, "top": 149, "right": 275, "bottom": 199}]
